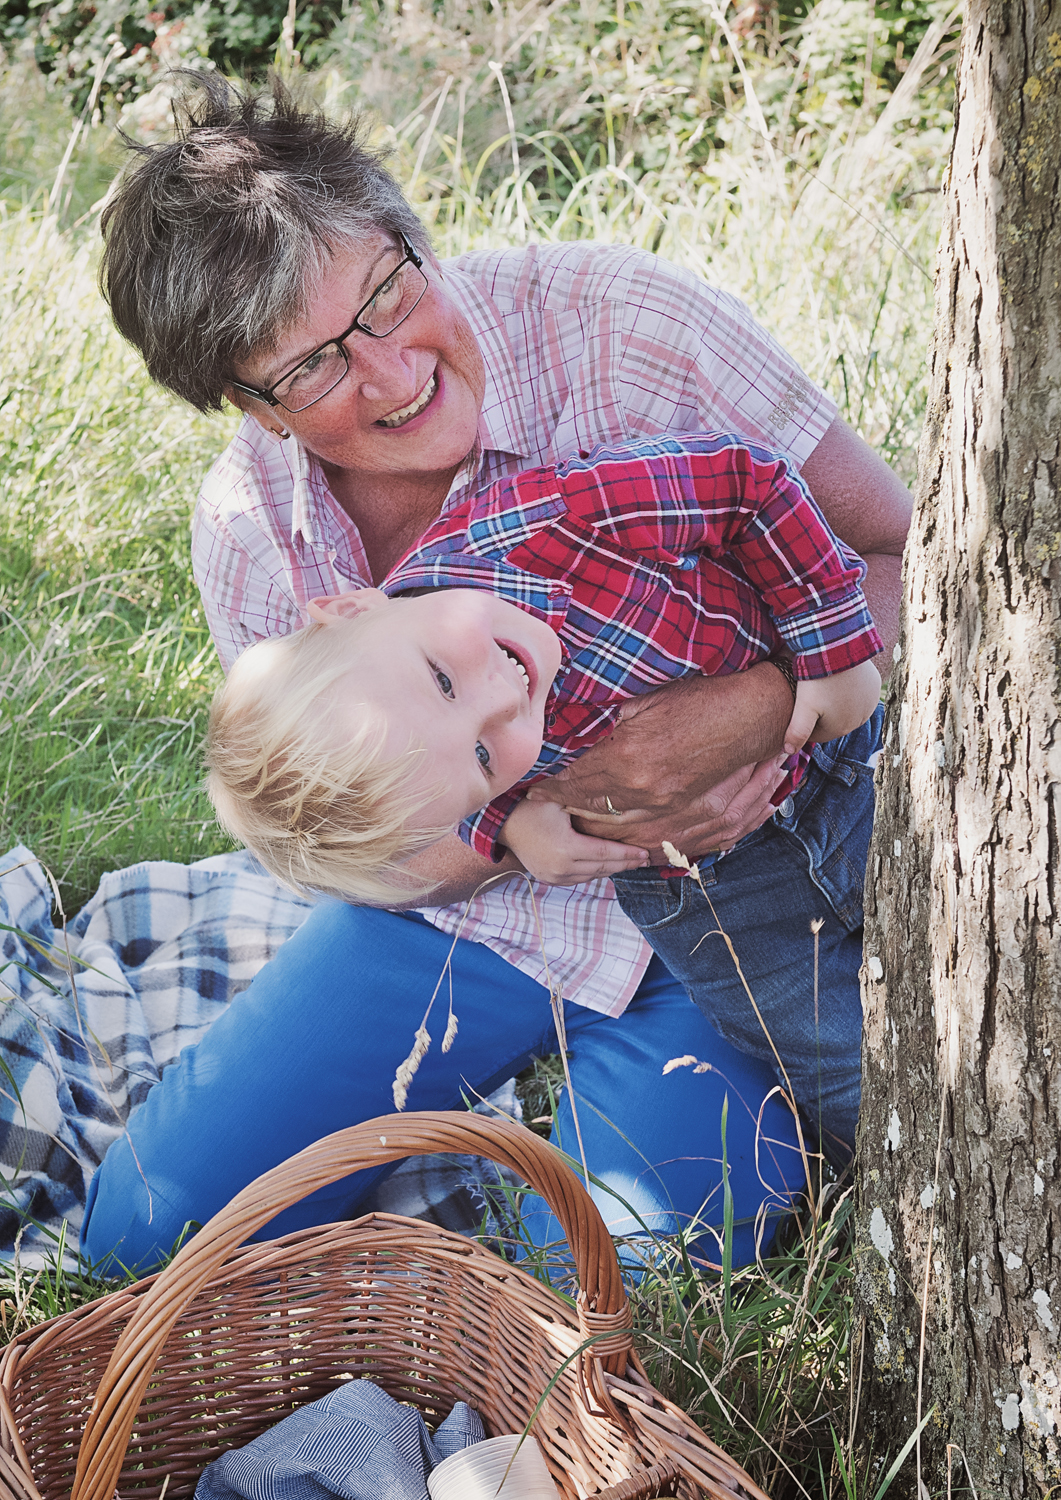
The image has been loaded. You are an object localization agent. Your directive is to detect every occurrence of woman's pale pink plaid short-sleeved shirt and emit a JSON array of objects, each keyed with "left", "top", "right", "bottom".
[{"left": 192, "top": 243, "right": 836, "bottom": 1016}]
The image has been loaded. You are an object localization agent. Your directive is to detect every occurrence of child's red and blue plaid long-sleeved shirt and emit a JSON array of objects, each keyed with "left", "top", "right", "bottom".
[{"left": 383, "top": 434, "right": 881, "bottom": 860}]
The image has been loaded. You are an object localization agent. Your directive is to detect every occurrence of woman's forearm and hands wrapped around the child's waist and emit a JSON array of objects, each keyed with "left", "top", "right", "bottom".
[{"left": 527, "top": 662, "right": 792, "bottom": 864}]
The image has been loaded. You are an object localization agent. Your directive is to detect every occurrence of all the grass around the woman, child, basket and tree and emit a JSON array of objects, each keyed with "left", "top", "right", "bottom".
[{"left": 0, "top": 0, "right": 947, "bottom": 1497}]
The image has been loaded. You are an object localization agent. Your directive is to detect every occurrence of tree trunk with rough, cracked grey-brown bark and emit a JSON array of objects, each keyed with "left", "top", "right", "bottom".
[{"left": 857, "top": 0, "right": 1061, "bottom": 1500}]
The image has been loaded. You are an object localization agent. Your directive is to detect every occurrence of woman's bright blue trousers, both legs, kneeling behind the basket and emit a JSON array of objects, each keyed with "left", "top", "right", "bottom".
[{"left": 81, "top": 900, "right": 803, "bottom": 1272}]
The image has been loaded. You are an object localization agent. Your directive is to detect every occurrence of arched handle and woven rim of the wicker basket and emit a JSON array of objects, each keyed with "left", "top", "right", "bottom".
[{"left": 0, "top": 1113, "right": 765, "bottom": 1500}]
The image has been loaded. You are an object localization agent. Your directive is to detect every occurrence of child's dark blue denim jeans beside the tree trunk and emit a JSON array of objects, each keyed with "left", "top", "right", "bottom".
[{"left": 615, "top": 708, "right": 884, "bottom": 1166}]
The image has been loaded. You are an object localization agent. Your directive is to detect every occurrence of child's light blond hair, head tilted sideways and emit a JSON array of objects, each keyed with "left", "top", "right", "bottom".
[{"left": 206, "top": 617, "right": 449, "bottom": 906}]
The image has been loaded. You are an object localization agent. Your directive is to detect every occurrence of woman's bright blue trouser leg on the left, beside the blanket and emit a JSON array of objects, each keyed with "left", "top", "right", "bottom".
[{"left": 83, "top": 902, "right": 549, "bottom": 1269}]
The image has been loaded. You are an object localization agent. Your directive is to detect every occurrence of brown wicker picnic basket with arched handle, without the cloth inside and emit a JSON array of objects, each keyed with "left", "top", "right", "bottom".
[{"left": 0, "top": 1113, "right": 765, "bottom": 1500}]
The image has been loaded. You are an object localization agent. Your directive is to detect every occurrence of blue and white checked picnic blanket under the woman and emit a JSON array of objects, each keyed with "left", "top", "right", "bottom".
[{"left": 0, "top": 845, "right": 519, "bottom": 1268}]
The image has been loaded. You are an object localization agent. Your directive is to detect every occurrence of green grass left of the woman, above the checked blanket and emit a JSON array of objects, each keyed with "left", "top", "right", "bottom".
[{"left": 0, "top": 126, "right": 240, "bottom": 912}]
